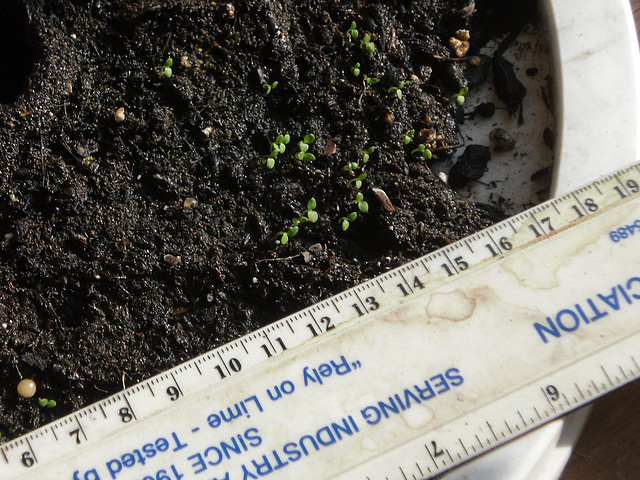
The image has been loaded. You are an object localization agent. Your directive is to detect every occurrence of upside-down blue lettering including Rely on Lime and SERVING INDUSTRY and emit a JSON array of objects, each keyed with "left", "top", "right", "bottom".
[{"left": 73, "top": 355, "right": 464, "bottom": 480}]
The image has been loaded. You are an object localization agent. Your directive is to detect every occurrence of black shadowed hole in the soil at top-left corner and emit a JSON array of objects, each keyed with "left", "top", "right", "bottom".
[{"left": 0, "top": 0, "right": 37, "bottom": 103}]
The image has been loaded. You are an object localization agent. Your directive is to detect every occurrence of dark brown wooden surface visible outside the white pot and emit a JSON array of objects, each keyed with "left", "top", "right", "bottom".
[{"left": 560, "top": 0, "right": 640, "bottom": 480}]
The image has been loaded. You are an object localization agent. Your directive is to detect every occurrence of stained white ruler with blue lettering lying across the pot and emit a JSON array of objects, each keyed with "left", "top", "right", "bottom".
[{"left": 0, "top": 164, "right": 640, "bottom": 480}]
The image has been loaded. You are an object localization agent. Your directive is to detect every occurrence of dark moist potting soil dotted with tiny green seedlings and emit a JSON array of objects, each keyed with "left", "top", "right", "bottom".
[{"left": 0, "top": 0, "right": 535, "bottom": 439}]
